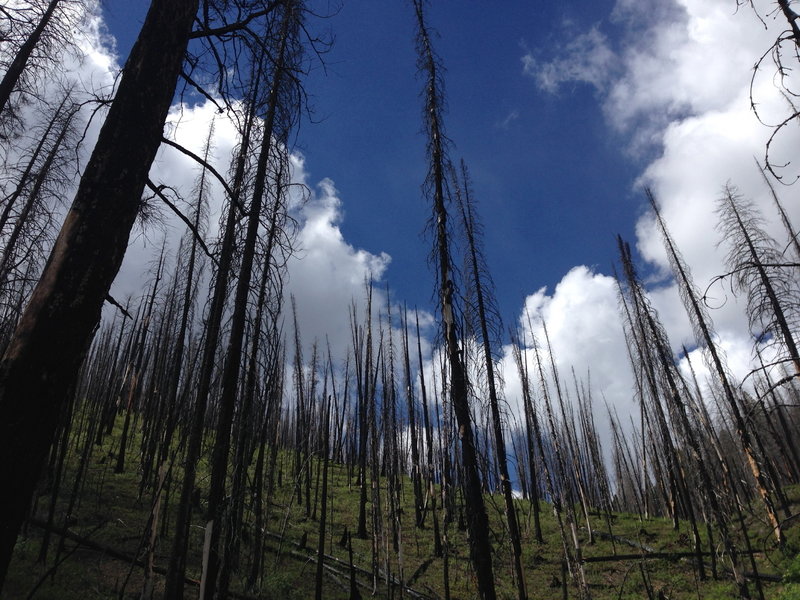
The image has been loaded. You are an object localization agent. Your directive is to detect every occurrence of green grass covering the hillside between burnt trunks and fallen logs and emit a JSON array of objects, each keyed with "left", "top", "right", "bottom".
[{"left": 3, "top": 412, "right": 800, "bottom": 600}]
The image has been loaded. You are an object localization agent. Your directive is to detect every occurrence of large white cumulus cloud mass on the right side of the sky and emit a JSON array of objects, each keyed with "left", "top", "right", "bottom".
[{"left": 523, "top": 0, "right": 800, "bottom": 440}]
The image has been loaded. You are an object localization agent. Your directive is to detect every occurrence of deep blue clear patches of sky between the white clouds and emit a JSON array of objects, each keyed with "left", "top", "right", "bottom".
[{"left": 104, "top": 0, "right": 642, "bottom": 324}]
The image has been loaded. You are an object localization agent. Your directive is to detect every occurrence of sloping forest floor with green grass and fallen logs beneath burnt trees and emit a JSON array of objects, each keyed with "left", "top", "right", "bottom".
[{"left": 2, "top": 412, "right": 800, "bottom": 600}]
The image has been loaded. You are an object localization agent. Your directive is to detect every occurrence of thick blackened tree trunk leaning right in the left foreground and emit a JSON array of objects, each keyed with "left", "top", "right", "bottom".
[{"left": 0, "top": 0, "right": 198, "bottom": 585}]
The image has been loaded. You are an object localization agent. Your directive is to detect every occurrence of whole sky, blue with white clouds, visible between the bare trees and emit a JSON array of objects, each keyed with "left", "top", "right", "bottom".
[{"left": 72, "top": 0, "right": 800, "bottom": 446}]
